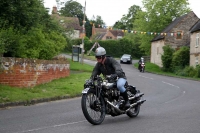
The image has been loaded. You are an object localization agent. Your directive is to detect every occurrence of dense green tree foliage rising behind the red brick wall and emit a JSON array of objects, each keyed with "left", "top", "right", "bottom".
[{"left": 0, "top": 0, "right": 66, "bottom": 59}]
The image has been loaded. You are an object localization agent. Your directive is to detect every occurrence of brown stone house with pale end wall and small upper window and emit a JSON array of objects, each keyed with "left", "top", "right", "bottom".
[{"left": 150, "top": 11, "right": 199, "bottom": 67}]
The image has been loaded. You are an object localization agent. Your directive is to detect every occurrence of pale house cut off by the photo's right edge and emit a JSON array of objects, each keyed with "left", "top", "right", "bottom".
[{"left": 190, "top": 20, "right": 200, "bottom": 67}]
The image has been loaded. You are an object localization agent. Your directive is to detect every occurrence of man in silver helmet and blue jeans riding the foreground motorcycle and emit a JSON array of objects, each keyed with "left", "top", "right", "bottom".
[{"left": 91, "top": 47, "right": 130, "bottom": 108}]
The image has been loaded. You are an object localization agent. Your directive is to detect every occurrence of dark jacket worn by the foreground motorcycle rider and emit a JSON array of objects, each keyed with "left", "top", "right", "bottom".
[{"left": 92, "top": 57, "right": 126, "bottom": 78}]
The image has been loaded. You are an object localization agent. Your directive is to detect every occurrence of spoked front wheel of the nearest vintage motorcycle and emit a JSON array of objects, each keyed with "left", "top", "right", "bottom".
[{"left": 81, "top": 90, "right": 105, "bottom": 125}]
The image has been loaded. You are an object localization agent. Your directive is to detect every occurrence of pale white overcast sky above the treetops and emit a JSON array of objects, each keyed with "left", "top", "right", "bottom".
[{"left": 44, "top": 0, "right": 200, "bottom": 26}]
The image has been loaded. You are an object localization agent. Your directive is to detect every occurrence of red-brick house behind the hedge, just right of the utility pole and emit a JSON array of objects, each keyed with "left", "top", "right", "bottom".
[{"left": 92, "top": 25, "right": 124, "bottom": 40}]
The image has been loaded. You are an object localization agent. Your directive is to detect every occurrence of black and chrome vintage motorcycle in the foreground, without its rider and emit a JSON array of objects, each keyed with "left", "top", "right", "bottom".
[{"left": 81, "top": 76, "right": 146, "bottom": 125}]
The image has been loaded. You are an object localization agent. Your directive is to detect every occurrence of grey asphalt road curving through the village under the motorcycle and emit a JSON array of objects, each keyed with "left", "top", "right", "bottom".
[{"left": 0, "top": 57, "right": 200, "bottom": 133}]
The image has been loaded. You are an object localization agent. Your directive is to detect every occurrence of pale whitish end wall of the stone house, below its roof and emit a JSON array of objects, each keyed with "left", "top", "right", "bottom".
[{"left": 151, "top": 40, "right": 164, "bottom": 67}]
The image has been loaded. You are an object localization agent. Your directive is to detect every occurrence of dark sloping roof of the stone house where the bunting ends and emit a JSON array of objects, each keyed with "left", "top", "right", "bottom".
[{"left": 151, "top": 14, "right": 187, "bottom": 42}]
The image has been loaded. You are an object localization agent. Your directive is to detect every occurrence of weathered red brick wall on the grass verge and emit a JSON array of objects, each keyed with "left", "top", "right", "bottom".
[{"left": 0, "top": 57, "right": 70, "bottom": 87}]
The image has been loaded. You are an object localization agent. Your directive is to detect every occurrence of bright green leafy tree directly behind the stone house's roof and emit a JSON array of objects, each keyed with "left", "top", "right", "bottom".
[{"left": 134, "top": 0, "right": 190, "bottom": 54}]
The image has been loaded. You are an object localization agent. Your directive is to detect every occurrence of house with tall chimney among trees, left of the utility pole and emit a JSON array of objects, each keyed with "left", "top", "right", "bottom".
[{"left": 51, "top": 6, "right": 83, "bottom": 39}]
